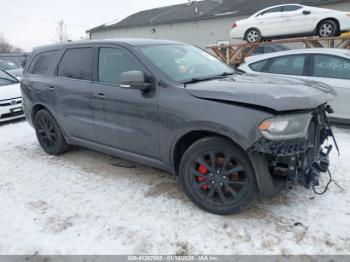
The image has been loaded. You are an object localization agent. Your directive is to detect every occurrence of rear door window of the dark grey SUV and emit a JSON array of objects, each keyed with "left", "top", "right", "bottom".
[{"left": 57, "top": 47, "right": 93, "bottom": 81}]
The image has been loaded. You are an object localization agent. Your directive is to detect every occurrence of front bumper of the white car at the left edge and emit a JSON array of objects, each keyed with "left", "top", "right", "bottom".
[{"left": 0, "top": 97, "right": 24, "bottom": 122}]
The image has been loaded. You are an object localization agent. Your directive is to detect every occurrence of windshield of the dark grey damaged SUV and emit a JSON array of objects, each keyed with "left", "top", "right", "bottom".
[{"left": 139, "top": 44, "right": 234, "bottom": 83}]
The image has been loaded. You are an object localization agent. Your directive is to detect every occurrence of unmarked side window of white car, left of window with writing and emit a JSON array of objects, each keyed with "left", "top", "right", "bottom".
[{"left": 267, "top": 55, "right": 305, "bottom": 76}]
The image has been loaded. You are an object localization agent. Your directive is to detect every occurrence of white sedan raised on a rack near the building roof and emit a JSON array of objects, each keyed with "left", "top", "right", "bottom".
[{"left": 230, "top": 4, "right": 350, "bottom": 43}]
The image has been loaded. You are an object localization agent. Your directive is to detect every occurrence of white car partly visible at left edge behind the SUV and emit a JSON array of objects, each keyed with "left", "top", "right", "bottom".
[{"left": 0, "top": 70, "right": 24, "bottom": 122}]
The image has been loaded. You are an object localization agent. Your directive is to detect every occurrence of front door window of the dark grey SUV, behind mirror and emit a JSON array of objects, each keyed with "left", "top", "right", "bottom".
[{"left": 98, "top": 48, "right": 143, "bottom": 85}]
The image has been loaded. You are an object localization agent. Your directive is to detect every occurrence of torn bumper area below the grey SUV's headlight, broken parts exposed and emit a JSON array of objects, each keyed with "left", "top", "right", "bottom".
[{"left": 249, "top": 106, "right": 333, "bottom": 188}]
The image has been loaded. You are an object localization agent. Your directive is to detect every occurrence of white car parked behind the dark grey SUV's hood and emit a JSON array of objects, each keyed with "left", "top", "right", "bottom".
[{"left": 238, "top": 48, "right": 350, "bottom": 123}]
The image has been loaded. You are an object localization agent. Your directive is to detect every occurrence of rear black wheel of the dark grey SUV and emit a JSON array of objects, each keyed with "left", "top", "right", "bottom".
[{"left": 34, "top": 109, "right": 69, "bottom": 155}]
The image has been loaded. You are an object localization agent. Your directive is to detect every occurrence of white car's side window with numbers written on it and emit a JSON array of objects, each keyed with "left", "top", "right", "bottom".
[{"left": 311, "top": 55, "right": 350, "bottom": 79}]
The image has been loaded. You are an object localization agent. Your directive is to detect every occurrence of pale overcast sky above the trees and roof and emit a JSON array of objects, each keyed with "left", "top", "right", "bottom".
[{"left": 0, "top": 0, "right": 187, "bottom": 51}]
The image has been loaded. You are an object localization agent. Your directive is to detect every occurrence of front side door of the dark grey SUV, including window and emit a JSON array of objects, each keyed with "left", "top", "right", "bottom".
[{"left": 92, "top": 46, "right": 159, "bottom": 158}]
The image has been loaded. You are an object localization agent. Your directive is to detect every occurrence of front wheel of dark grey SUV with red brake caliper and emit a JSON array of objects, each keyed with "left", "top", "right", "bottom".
[{"left": 179, "top": 137, "right": 258, "bottom": 215}]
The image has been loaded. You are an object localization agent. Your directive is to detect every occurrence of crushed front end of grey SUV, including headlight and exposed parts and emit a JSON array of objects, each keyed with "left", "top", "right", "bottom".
[{"left": 249, "top": 105, "right": 336, "bottom": 188}]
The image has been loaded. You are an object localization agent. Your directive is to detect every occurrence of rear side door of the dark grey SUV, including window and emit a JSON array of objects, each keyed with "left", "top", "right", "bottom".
[{"left": 51, "top": 45, "right": 96, "bottom": 141}]
